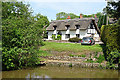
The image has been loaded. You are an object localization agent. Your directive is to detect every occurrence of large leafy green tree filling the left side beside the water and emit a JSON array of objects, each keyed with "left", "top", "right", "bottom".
[{"left": 2, "top": 2, "right": 48, "bottom": 70}]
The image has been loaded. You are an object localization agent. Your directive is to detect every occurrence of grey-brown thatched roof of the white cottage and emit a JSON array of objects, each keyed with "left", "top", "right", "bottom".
[{"left": 46, "top": 18, "right": 98, "bottom": 31}]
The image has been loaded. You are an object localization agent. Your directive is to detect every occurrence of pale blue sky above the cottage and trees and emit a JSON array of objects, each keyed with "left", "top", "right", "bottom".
[{"left": 20, "top": 0, "right": 106, "bottom": 21}]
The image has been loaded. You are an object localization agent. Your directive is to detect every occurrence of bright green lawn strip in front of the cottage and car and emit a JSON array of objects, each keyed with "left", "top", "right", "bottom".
[{"left": 41, "top": 41, "right": 102, "bottom": 53}]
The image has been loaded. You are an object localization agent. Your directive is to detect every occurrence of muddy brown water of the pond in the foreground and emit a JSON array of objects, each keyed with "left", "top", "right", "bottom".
[{"left": 2, "top": 66, "right": 118, "bottom": 78}]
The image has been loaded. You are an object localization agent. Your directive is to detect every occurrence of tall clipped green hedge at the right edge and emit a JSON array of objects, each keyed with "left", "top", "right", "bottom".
[{"left": 101, "top": 21, "right": 120, "bottom": 68}]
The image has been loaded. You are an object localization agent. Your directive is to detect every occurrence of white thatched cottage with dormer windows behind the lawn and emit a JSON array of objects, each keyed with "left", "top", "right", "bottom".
[{"left": 46, "top": 15, "right": 100, "bottom": 41}]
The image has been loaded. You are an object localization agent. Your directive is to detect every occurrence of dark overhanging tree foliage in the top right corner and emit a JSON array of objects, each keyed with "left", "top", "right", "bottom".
[{"left": 104, "top": 1, "right": 120, "bottom": 20}]
